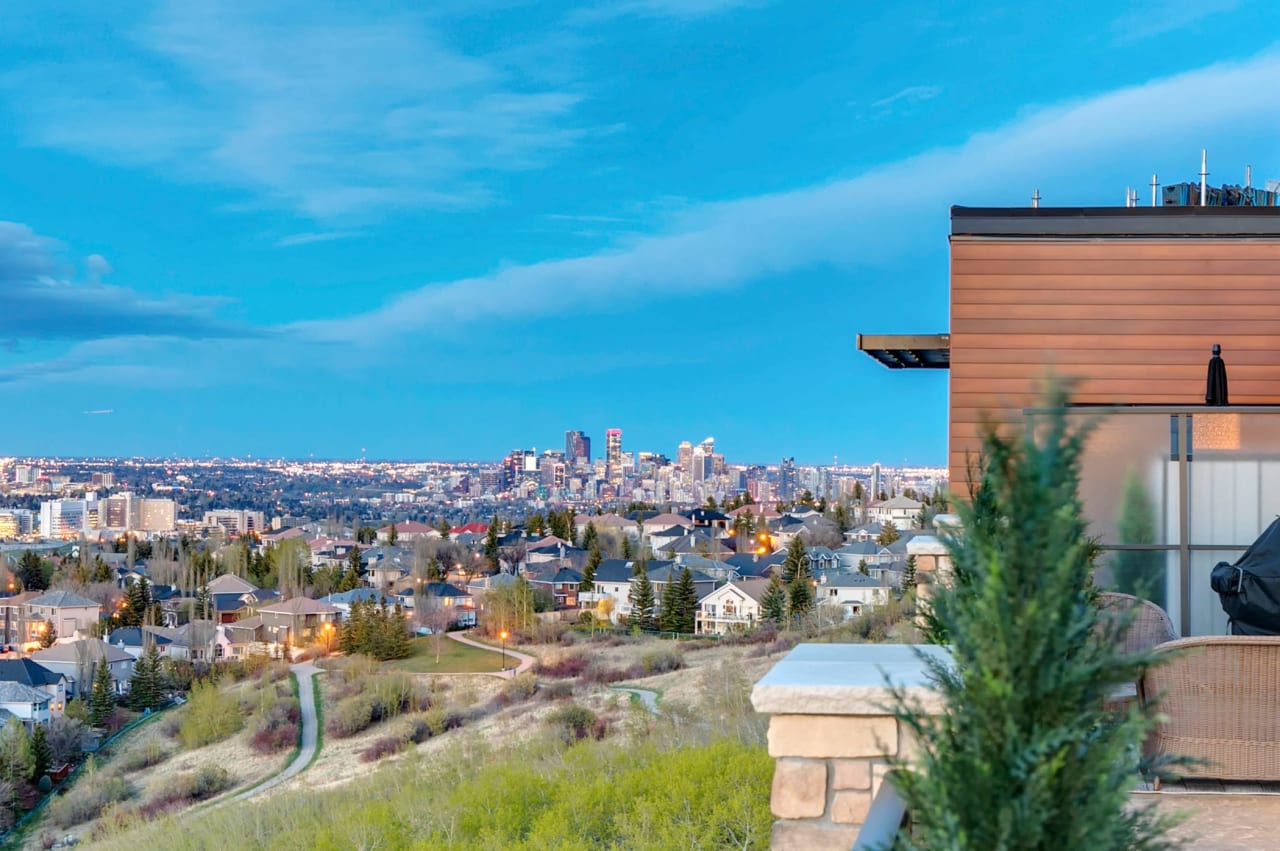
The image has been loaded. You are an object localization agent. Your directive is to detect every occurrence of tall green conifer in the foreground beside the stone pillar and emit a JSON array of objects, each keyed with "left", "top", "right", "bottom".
[{"left": 895, "top": 390, "right": 1169, "bottom": 851}]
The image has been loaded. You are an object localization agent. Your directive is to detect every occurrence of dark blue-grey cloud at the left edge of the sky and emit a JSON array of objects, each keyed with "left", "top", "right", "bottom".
[{"left": 0, "top": 221, "right": 257, "bottom": 342}]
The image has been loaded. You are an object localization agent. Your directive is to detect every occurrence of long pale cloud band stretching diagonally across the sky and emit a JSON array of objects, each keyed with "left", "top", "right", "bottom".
[{"left": 0, "top": 52, "right": 1280, "bottom": 383}]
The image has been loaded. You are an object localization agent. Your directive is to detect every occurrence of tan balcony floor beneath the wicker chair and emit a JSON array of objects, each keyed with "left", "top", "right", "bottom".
[{"left": 1133, "top": 781, "right": 1280, "bottom": 851}]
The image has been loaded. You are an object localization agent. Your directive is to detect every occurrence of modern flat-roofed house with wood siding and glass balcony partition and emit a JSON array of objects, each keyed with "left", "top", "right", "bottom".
[{"left": 858, "top": 200, "right": 1280, "bottom": 635}]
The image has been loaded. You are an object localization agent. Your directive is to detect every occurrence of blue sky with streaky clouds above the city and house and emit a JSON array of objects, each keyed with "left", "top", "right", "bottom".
[{"left": 0, "top": 0, "right": 1280, "bottom": 465}]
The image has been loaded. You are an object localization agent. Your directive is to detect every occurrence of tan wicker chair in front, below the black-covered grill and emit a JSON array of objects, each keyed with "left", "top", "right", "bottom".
[{"left": 1139, "top": 636, "right": 1280, "bottom": 782}]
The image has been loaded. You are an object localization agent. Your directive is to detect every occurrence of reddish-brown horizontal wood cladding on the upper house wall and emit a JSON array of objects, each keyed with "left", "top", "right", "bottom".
[{"left": 950, "top": 232, "right": 1280, "bottom": 494}]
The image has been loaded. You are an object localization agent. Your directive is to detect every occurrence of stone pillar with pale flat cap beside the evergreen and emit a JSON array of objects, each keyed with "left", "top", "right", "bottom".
[{"left": 751, "top": 644, "right": 946, "bottom": 851}]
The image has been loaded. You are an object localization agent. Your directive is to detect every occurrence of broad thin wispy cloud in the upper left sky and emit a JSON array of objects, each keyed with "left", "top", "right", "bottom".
[{"left": 0, "top": 0, "right": 590, "bottom": 220}]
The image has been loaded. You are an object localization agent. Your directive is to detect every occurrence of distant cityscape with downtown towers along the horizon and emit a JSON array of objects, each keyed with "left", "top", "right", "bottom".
[{"left": 0, "top": 429, "right": 947, "bottom": 540}]
